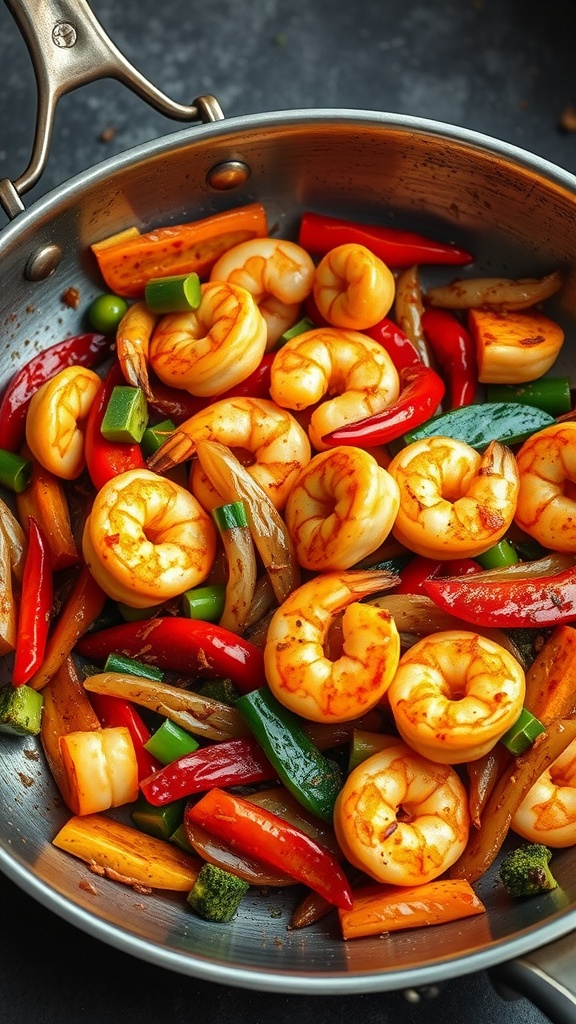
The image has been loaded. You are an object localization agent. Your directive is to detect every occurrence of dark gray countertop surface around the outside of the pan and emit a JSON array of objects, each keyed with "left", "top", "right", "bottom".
[{"left": 0, "top": 0, "right": 576, "bottom": 1024}]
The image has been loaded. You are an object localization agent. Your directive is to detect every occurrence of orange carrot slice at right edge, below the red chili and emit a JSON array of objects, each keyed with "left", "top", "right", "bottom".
[{"left": 524, "top": 626, "right": 576, "bottom": 725}]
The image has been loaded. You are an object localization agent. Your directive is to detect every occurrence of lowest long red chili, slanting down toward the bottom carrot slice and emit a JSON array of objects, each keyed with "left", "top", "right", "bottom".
[{"left": 184, "top": 788, "right": 353, "bottom": 908}]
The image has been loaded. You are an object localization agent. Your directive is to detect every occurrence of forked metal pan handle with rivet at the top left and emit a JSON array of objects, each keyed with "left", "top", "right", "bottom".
[{"left": 2, "top": 0, "right": 223, "bottom": 216}]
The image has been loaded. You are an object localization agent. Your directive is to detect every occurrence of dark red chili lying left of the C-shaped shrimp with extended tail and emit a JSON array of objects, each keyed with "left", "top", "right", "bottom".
[{"left": 76, "top": 615, "right": 265, "bottom": 693}]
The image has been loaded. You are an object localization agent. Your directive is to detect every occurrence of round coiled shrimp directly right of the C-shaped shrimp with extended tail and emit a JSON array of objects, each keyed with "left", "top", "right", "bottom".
[{"left": 388, "top": 630, "right": 526, "bottom": 765}]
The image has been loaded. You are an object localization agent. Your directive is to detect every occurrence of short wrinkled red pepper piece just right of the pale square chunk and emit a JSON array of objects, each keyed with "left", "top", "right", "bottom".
[{"left": 140, "top": 736, "right": 277, "bottom": 807}]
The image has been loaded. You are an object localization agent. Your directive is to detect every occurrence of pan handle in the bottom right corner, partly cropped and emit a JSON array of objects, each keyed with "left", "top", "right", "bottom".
[{"left": 489, "top": 933, "right": 576, "bottom": 1024}]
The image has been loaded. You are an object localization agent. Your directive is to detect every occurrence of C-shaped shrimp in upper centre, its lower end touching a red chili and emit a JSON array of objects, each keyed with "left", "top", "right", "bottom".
[{"left": 270, "top": 327, "right": 400, "bottom": 452}]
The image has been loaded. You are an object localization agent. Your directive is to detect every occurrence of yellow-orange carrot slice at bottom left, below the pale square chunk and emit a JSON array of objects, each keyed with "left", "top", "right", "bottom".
[{"left": 52, "top": 814, "right": 202, "bottom": 892}]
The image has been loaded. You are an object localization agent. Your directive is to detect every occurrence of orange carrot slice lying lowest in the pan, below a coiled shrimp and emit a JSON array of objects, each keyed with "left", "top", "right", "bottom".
[{"left": 338, "top": 879, "right": 486, "bottom": 939}]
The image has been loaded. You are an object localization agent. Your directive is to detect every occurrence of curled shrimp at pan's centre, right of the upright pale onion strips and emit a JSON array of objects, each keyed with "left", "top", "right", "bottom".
[{"left": 284, "top": 445, "right": 400, "bottom": 572}]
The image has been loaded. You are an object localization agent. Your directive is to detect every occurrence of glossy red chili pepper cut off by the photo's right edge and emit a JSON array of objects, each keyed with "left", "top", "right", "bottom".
[{"left": 425, "top": 566, "right": 576, "bottom": 629}]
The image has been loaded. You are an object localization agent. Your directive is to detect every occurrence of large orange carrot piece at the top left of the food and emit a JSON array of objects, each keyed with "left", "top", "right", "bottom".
[{"left": 91, "top": 203, "right": 268, "bottom": 298}]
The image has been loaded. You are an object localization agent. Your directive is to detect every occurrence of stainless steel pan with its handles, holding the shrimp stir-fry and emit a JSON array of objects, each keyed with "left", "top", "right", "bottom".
[{"left": 0, "top": 0, "right": 576, "bottom": 1022}]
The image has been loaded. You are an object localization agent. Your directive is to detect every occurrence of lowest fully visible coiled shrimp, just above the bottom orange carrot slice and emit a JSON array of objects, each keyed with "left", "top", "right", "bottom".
[{"left": 334, "top": 743, "right": 469, "bottom": 886}]
